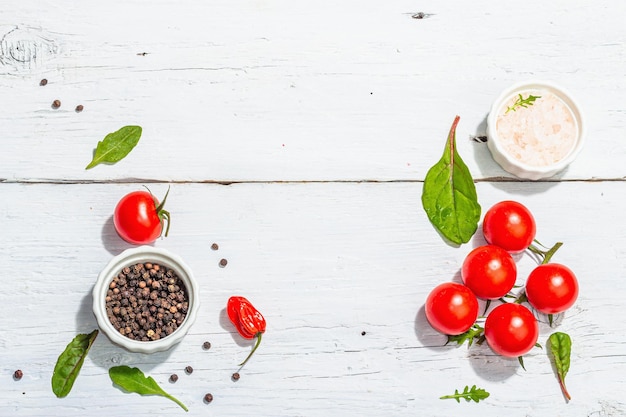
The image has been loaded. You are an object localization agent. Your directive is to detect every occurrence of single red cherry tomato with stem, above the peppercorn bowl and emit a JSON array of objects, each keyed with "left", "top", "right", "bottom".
[{"left": 113, "top": 190, "right": 170, "bottom": 245}]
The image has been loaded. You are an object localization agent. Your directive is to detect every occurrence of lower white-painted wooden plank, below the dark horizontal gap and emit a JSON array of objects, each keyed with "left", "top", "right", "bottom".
[{"left": 0, "top": 182, "right": 626, "bottom": 416}]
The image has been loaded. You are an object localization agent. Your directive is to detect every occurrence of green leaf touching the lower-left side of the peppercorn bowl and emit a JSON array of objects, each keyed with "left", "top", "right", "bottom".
[{"left": 51, "top": 329, "right": 98, "bottom": 398}]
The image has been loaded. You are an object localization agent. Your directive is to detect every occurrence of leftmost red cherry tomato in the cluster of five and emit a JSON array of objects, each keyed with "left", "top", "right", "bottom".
[{"left": 424, "top": 282, "right": 478, "bottom": 335}]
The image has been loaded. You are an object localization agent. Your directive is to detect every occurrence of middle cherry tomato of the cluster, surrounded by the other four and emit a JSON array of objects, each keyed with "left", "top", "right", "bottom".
[{"left": 461, "top": 245, "right": 517, "bottom": 300}]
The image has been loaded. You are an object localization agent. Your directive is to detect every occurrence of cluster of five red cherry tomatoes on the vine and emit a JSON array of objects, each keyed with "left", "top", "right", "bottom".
[{"left": 425, "top": 201, "right": 578, "bottom": 357}]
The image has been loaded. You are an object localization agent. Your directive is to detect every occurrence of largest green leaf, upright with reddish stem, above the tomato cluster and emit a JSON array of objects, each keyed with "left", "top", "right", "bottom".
[{"left": 422, "top": 116, "right": 481, "bottom": 244}]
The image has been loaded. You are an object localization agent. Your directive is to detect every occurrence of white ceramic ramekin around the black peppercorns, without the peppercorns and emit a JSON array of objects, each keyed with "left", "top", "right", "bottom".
[{"left": 93, "top": 246, "right": 200, "bottom": 353}]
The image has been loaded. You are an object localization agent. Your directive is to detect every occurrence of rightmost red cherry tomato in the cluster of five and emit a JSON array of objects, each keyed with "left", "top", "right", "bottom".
[{"left": 526, "top": 263, "right": 578, "bottom": 314}]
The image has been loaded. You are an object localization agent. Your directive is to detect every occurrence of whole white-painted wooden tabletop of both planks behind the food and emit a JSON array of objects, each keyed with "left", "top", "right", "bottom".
[{"left": 0, "top": 0, "right": 626, "bottom": 417}]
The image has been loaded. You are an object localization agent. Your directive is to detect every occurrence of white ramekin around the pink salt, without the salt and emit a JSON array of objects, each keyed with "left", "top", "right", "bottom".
[{"left": 487, "top": 81, "right": 586, "bottom": 180}]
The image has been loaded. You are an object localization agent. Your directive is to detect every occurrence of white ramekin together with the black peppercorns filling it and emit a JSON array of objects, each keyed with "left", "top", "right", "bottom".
[{"left": 93, "top": 246, "right": 199, "bottom": 353}]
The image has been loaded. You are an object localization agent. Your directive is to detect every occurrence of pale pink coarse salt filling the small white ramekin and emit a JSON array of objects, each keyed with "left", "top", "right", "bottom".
[{"left": 496, "top": 90, "right": 578, "bottom": 166}]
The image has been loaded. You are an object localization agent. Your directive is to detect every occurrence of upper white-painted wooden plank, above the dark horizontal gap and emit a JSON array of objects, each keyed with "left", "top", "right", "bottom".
[{"left": 0, "top": 0, "right": 626, "bottom": 182}]
